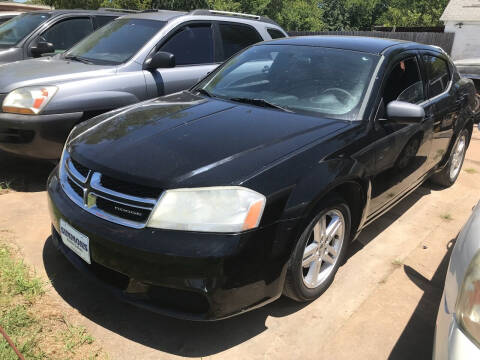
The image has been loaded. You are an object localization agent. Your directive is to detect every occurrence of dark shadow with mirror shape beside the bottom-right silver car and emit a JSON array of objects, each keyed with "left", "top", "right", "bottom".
[{"left": 388, "top": 239, "right": 456, "bottom": 360}]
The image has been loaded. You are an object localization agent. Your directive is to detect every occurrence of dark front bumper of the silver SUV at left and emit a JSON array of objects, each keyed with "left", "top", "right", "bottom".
[{"left": 0, "top": 112, "right": 83, "bottom": 160}]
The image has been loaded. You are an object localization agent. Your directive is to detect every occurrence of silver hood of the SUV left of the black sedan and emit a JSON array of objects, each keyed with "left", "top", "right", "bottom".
[{"left": 0, "top": 57, "right": 116, "bottom": 93}]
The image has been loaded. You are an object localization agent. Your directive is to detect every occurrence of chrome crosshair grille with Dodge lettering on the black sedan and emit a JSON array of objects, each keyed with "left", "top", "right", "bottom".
[{"left": 60, "top": 152, "right": 161, "bottom": 229}]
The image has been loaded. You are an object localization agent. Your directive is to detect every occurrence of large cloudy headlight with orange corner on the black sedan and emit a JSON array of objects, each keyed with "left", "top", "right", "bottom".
[{"left": 147, "top": 186, "right": 266, "bottom": 232}]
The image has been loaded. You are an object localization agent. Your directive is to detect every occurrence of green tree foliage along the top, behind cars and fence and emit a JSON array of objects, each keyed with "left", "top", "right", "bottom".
[{"left": 30, "top": 0, "right": 448, "bottom": 31}]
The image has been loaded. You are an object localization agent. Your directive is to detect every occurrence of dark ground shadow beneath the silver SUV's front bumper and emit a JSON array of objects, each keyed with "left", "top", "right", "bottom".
[{"left": 0, "top": 151, "right": 55, "bottom": 192}]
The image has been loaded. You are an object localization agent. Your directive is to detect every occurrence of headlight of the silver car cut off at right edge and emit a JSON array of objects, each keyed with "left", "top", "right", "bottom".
[{"left": 455, "top": 252, "right": 480, "bottom": 344}]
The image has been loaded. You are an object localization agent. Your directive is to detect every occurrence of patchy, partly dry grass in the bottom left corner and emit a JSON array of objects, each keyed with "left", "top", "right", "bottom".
[{"left": 0, "top": 238, "right": 108, "bottom": 360}]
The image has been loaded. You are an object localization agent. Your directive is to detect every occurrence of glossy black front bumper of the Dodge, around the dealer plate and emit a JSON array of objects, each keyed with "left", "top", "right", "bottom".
[{"left": 48, "top": 170, "right": 293, "bottom": 320}]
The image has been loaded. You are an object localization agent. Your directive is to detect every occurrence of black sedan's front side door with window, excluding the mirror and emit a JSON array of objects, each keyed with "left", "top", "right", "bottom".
[{"left": 369, "top": 52, "right": 433, "bottom": 215}]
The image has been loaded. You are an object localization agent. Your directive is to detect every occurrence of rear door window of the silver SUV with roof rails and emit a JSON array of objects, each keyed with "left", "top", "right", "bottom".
[{"left": 219, "top": 23, "right": 263, "bottom": 60}]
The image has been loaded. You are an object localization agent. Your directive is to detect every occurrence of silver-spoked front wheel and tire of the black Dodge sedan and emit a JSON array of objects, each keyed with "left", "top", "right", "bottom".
[{"left": 284, "top": 196, "right": 351, "bottom": 302}]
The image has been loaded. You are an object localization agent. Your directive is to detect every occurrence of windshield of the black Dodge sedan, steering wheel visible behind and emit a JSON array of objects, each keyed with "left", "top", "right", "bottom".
[{"left": 194, "top": 44, "right": 379, "bottom": 120}]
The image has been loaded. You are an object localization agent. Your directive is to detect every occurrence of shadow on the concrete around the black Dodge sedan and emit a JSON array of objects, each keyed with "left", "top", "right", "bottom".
[{"left": 43, "top": 183, "right": 436, "bottom": 357}]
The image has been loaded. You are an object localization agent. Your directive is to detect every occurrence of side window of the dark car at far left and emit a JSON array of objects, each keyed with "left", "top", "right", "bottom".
[{"left": 41, "top": 17, "right": 93, "bottom": 52}]
